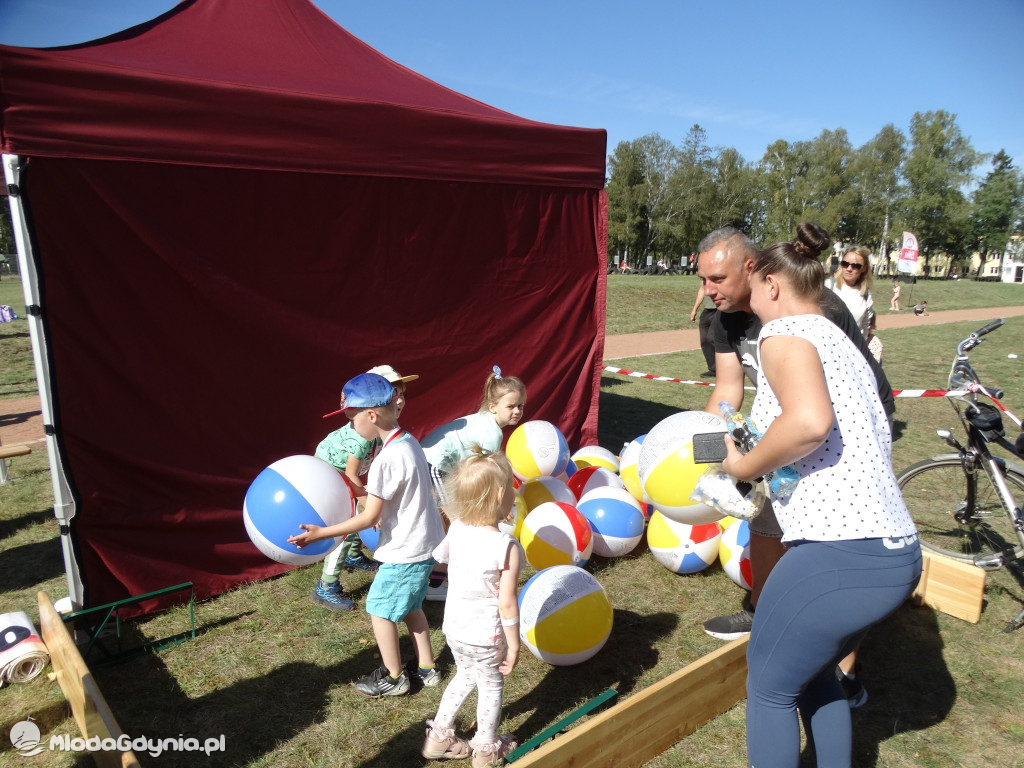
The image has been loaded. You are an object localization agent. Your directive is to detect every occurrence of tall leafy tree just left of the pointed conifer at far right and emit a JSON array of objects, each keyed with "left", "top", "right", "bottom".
[{"left": 905, "top": 110, "right": 979, "bottom": 273}]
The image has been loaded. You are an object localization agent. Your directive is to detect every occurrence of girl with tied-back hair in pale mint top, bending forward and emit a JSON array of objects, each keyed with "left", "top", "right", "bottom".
[{"left": 423, "top": 366, "right": 526, "bottom": 600}]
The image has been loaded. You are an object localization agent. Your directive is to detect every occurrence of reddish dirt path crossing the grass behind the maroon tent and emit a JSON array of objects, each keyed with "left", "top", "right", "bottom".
[{"left": 0, "top": 306, "right": 1024, "bottom": 445}]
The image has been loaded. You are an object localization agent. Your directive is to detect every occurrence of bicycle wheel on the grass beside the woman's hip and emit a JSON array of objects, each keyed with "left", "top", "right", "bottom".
[{"left": 896, "top": 456, "right": 1024, "bottom": 562}]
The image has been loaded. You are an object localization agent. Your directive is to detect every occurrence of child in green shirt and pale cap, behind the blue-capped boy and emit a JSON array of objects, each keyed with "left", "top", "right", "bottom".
[{"left": 311, "top": 366, "right": 420, "bottom": 610}]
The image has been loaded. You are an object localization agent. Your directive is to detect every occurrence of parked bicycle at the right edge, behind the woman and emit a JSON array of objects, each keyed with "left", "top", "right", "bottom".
[{"left": 896, "top": 318, "right": 1024, "bottom": 632}]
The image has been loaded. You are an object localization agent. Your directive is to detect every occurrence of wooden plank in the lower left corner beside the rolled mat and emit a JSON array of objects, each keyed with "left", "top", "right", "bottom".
[{"left": 38, "top": 591, "right": 139, "bottom": 768}]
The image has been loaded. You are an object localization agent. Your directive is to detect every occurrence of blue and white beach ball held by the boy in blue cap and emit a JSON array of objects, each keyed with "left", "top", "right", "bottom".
[{"left": 242, "top": 456, "right": 355, "bottom": 565}]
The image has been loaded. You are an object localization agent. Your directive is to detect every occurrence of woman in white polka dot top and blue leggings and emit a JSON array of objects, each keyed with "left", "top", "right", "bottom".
[{"left": 723, "top": 223, "right": 921, "bottom": 768}]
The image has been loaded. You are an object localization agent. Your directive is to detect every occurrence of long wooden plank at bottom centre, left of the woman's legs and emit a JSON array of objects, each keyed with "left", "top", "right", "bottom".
[{"left": 514, "top": 636, "right": 748, "bottom": 768}]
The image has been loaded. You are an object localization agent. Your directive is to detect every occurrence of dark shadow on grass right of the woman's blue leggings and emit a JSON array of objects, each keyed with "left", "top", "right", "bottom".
[{"left": 839, "top": 605, "right": 956, "bottom": 768}]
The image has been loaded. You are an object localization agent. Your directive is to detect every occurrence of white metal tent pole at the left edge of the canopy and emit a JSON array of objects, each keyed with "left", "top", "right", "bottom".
[{"left": 3, "top": 154, "right": 84, "bottom": 607}]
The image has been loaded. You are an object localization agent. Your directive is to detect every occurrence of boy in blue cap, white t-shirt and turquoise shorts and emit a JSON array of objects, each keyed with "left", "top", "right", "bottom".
[{"left": 288, "top": 374, "right": 444, "bottom": 698}]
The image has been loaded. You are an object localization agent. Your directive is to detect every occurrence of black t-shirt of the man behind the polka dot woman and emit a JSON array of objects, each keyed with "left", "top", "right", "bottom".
[{"left": 711, "top": 291, "right": 896, "bottom": 416}]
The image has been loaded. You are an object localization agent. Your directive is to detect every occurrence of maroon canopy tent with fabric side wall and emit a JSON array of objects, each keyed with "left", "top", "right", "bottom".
[{"left": 0, "top": 0, "right": 606, "bottom": 605}]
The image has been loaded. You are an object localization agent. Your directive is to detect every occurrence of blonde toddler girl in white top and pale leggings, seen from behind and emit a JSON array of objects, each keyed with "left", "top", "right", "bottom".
[{"left": 423, "top": 449, "right": 522, "bottom": 768}]
